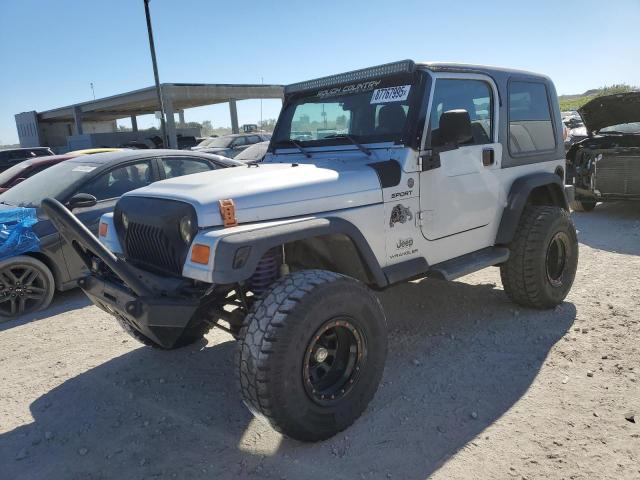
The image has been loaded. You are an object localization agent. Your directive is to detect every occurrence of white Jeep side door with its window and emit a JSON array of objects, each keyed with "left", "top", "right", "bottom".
[{"left": 420, "top": 74, "right": 502, "bottom": 242}]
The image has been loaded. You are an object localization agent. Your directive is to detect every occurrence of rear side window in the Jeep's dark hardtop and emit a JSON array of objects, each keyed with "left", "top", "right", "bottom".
[{"left": 509, "top": 82, "right": 556, "bottom": 155}]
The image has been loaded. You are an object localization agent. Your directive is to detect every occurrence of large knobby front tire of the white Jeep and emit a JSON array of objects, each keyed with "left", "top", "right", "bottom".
[{"left": 235, "top": 270, "right": 387, "bottom": 442}]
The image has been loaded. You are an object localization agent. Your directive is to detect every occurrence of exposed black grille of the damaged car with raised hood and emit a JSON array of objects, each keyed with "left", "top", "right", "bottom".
[{"left": 595, "top": 154, "right": 640, "bottom": 195}]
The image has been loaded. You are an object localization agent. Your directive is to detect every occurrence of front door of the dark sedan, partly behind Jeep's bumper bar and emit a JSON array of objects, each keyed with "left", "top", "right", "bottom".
[{"left": 62, "top": 159, "right": 156, "bottom": 279}]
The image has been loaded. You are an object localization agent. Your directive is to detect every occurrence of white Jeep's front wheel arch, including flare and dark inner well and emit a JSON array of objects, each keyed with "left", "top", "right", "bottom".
[{"left": 213, "top": 217, "right": 388, "bottom": 288}]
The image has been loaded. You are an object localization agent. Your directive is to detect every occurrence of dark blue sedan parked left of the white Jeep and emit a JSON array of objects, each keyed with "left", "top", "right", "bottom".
[{"left": 0, "top": 150, "right": 240, "bottom": 321}]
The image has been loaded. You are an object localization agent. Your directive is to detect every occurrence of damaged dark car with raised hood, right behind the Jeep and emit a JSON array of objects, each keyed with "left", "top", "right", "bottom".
[{"left": 567, "top": 91, "right": 640, "bottom": 211}]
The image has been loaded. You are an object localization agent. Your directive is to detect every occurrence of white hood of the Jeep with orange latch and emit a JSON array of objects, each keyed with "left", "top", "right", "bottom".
[{"left": 125, "top": 162, "right": 382, "bottom": 228}]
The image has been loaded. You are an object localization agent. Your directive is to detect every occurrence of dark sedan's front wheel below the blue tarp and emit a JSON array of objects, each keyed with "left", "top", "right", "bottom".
[{"left": 0, "top": 255, "right": 56, "bottom": 323}]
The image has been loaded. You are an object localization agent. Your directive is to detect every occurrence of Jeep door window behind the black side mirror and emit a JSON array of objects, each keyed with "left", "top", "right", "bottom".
[{"left": 429, "top": 78, "right": 494, "bottom": 147}]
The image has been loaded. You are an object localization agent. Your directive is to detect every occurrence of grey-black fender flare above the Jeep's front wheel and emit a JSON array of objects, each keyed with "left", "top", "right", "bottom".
[{"left": 213, "top": 217, "right": 388, "bottom": 288}]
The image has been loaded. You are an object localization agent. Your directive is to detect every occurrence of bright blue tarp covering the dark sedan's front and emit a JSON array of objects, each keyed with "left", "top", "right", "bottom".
[{"left": 0, "top": 207, "right": 40, "bottom": 260}]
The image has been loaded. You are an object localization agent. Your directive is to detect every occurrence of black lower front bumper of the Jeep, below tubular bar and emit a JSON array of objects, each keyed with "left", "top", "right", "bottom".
[{"left": 78, "top": 275, "right": 200, "bottom": 348}]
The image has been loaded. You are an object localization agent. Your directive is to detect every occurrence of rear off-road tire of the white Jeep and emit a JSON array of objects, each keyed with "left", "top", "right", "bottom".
[{"left": 500, "top": 206, "right": 578, "bottom": 309}]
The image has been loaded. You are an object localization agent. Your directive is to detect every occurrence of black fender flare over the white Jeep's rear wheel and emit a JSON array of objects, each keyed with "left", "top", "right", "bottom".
[{"left": 495, "top": 172, "right": 569, "bottom": 245}]
